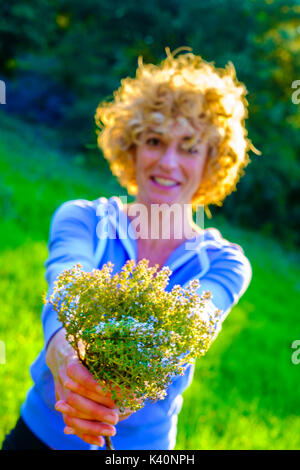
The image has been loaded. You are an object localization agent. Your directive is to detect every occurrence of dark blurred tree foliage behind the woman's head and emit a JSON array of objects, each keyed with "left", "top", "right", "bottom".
[{"left": 0, "top": 0, "right": 300, "bottom": 245}]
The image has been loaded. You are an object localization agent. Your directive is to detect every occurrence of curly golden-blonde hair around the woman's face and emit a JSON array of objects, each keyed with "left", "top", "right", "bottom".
[{"left": 95, "top": 48, "right": 260, "bottom": 217}]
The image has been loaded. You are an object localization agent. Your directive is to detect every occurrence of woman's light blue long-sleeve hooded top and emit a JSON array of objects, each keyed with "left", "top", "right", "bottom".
[{"left": 21, "top": 197, "right": 252, "bottom": 450}]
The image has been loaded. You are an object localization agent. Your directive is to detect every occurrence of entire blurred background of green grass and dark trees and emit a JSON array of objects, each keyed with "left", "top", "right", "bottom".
[{"left": 0, "top": 0, "right": 300, "bottom": 449}]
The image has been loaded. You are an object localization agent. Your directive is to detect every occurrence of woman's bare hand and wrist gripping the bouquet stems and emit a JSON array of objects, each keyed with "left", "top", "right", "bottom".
[{"left": 46, "top": 329, "right": 123, "bottom": 446}]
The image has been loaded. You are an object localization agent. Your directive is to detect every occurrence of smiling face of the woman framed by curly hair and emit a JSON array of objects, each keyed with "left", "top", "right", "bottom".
[{"left": 135, "top": 122, "right": 208, "bottom": 205}]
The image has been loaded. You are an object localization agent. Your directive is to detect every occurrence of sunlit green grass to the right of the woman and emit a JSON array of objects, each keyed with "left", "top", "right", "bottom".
[{"left": 177, "top": 221, "right": 300, "bottom": 449}]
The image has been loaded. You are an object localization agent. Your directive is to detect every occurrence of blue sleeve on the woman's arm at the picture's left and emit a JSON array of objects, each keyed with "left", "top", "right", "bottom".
[{"left": 42, "top": 199, "right": 95, "bottom": 347}]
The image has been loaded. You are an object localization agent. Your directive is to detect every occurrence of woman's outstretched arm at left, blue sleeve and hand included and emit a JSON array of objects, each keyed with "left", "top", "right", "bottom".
[{"left": 42, "top": 200, "right": 135, "bottom": 446}]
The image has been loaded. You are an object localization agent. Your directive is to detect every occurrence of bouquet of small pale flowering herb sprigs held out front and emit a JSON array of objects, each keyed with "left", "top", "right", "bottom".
[{"left": 44, "top": 259, "right": 221, "bottom": 448}]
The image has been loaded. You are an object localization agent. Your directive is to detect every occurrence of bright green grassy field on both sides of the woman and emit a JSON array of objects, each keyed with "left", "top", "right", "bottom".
[{"left": 0, "top": 111, "right": 300, "bottom": 450}]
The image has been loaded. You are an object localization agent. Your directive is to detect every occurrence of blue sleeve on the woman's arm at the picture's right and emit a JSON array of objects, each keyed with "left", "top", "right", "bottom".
[{"left": 198, "top": 243, "right": 252, "bottom": 330}]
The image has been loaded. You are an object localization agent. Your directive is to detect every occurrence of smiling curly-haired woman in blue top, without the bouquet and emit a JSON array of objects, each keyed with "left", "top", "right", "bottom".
[{"left": 3, "top": 50, "right": 255, "bottom": 450}]
